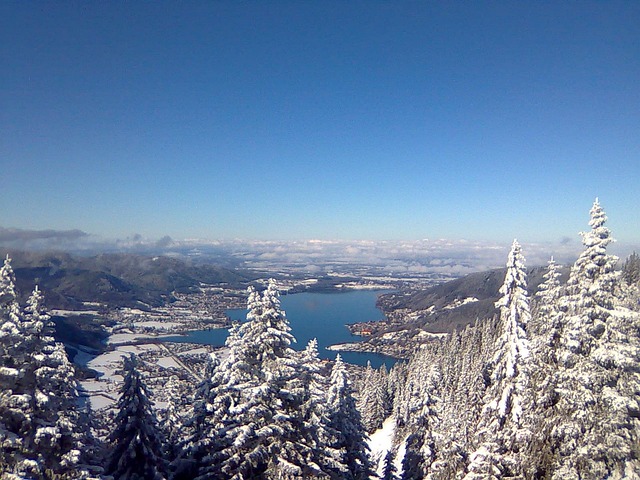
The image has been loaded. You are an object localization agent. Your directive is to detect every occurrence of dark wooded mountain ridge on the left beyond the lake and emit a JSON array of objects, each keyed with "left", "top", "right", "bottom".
[{"left": 8, "top": 251, "right": 253, "bottom": 308}]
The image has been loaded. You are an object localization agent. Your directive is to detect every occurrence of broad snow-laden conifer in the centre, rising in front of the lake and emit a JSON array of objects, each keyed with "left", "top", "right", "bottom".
[{"left": 198, "top": 281, "right": 326, "bottom": 480}]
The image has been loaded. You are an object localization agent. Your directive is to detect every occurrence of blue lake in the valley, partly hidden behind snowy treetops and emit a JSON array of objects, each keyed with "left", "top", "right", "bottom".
[{"left": 165, "top": 290, "right": 395, "bottom": 368}]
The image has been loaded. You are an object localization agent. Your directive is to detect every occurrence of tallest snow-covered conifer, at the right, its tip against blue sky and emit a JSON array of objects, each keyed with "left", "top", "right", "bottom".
[{"left": 550, "top": 199, "right": 640, "bottom": 479}]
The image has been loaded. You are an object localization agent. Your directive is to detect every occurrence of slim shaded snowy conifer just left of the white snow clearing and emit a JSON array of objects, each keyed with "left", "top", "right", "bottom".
[{"left": 327, "top": 354, "right": 373, "bottom": 480}]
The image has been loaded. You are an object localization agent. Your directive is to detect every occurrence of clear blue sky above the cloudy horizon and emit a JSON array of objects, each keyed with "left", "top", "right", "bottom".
[{"left": 0, "top": 0, "right": 640, "bottom": 241}]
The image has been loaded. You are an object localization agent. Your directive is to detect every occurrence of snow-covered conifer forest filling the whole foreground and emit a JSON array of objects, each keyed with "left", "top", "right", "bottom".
[{"left": 0, "top": 201, "right": 640, "bottom": 480}]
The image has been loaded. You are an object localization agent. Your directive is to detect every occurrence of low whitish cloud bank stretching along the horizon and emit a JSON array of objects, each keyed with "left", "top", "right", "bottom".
[{"left": 0, "top": 227, "right": 640, "bottom": 276}]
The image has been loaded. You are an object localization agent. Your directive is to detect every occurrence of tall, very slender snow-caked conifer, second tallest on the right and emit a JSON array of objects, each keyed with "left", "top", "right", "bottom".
[{"left": 465, "top": 240, "right": 531, "bottom": 480}]
